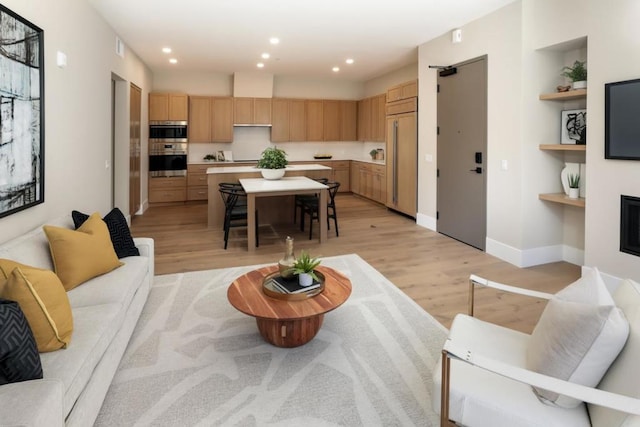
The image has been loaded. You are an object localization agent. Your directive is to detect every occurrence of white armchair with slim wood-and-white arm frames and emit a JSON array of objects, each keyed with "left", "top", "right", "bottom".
[{"left": 433, "top": 270, "right": 640, "bottom": 427}]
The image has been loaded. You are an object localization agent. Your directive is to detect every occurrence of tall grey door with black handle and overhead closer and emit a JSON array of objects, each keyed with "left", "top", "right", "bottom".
[{"left": 437, "top": 57, "right": 487, "bottom": 250}]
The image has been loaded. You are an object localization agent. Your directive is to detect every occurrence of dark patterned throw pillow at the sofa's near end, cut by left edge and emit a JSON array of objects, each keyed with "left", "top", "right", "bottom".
[{"left": 0, "top": 298, "right": 42, "bottom": 385}]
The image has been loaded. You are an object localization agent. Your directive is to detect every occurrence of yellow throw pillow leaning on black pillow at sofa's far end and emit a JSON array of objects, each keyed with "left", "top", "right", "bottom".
[{"left": 43, "top": 212, "right": 123, "bottom": 291}]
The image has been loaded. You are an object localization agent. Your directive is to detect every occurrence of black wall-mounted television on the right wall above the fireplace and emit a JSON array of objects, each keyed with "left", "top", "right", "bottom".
[{"left": 604, "top": 79, "right": 640, "bottom": 160}]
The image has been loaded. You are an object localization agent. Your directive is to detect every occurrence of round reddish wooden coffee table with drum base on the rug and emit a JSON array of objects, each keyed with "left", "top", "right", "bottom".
[{"left": 227, "top": 265, "right": 351, "bottom": 347}]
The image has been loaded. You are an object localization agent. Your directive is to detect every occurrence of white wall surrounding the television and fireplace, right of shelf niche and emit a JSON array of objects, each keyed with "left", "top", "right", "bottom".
[{"left": 585, "top": 0, "right": 640, "bottom": 281}]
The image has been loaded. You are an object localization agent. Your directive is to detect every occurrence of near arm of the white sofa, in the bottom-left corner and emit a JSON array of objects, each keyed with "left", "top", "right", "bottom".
[{"left": 0, "top": 380, "right": 64, "bottom": 427}]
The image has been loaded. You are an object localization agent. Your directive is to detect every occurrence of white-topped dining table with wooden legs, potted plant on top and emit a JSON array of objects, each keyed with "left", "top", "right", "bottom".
[{"left": 239, "top": 176, "right": 328, "bottom": 252}]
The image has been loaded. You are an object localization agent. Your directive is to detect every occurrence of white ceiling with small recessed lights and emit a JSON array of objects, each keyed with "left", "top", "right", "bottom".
[{"left": 88, "top": 0, "right": 514, "bottom": 81}]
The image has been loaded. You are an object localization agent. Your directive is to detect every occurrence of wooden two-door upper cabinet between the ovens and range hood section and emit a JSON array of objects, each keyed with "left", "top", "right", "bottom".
[{"left": 189, "top": 96, "right": 233, "bottom": 143}]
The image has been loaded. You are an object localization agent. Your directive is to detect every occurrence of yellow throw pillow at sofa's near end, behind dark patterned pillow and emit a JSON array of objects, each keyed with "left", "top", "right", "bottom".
[{"left": 0, "top": 260, "right": 73, "bottom": 353}]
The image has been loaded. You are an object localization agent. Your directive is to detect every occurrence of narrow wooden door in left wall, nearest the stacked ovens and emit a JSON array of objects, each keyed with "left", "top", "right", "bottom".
[{"left": 129, "top": 84, "right": 142, "bottom": 218}]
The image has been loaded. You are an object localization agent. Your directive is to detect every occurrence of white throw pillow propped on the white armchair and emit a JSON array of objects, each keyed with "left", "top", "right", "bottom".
[{"left": 527, "top": 268, "right": 629, "bottom": 408}]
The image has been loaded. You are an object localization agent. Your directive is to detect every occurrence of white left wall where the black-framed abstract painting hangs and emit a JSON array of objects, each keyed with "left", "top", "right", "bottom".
[{"left": 0, "top": 0, "right": 151, "bottom": 242}]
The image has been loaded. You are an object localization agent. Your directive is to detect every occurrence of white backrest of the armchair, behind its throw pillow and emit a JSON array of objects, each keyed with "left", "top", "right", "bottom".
[{"left": 588, "top": 280, "right": 640, "bottom": 427}]
